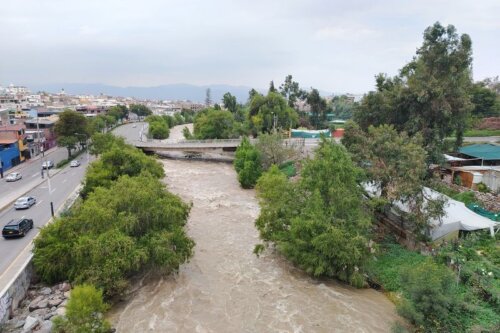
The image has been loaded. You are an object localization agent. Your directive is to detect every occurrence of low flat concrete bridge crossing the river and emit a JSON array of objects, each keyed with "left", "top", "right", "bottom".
[{"left": 132, "top": 139, "right": 305, "bottom": 153}]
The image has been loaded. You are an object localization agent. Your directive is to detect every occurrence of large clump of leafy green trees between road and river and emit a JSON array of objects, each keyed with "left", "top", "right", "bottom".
[{"left": 33, "top": 134, "right": 194, "bottom": 298}]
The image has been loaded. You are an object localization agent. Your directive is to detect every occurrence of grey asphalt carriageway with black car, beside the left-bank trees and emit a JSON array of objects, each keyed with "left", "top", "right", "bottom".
[{"left": 0, "top": 155, "right": 87, "bottom": 274}]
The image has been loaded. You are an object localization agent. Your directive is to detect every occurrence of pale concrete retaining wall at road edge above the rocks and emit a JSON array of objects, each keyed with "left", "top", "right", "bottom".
[{"left": 0, "top": 257, "right": 34, "bottom": 326}]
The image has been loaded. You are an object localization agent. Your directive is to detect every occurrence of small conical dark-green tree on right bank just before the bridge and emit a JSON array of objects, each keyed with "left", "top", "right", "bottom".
[{"left": 234, "top": 137, "right": 262, "bottom": 188}]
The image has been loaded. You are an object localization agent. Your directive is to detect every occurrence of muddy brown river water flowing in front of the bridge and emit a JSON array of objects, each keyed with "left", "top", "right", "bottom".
[{"left": 111, "top": 154, "right": 397, "bottom": 333}]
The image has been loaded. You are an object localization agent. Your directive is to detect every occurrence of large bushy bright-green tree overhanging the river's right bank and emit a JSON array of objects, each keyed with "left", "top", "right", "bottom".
[{"left": 256, "top": 139, "right": 370, "bottom": 286}]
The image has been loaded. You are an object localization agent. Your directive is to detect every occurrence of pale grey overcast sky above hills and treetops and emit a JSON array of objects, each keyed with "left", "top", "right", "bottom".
[{"left": 0, "top": 0, "right": 500, "bottom": 93}]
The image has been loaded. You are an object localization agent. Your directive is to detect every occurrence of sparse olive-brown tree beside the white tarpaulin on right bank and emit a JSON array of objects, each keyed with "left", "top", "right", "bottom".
[{"left": 342, "top": 122, "right": 444, "bottom": 235}]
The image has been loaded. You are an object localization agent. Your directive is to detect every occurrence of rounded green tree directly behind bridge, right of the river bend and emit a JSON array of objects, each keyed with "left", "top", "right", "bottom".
[{"left": 193, "top": 109, "right": 234, "bottom": 139}]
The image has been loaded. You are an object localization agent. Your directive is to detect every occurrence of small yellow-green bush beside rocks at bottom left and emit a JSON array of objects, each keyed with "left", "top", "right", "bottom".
[{"left": 53, "top": 284, "right": 111, "bottom": 333}]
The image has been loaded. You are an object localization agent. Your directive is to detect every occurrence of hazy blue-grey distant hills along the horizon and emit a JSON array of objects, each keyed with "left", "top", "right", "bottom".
[{"left": 28, "top": 83, "right": 265, "bottom": 103}]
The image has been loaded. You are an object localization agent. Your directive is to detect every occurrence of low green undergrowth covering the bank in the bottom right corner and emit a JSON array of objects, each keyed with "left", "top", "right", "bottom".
[{"left": 366, "top": 234, "right": 500, "bottom": 332}]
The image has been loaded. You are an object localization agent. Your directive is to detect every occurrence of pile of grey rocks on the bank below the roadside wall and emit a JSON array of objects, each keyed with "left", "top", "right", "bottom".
[{"left": 1, "top": 282, "right": 71, "bottom": 333}]
